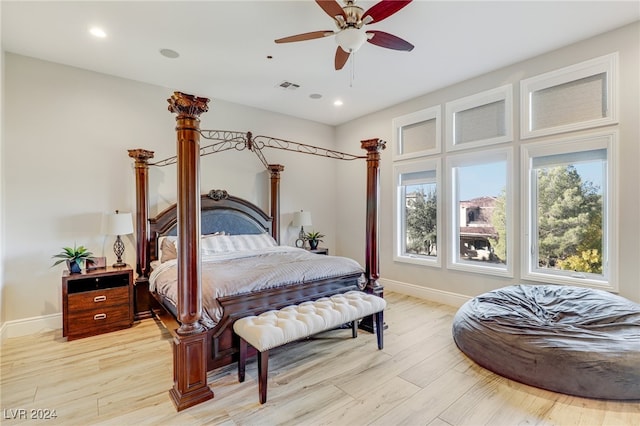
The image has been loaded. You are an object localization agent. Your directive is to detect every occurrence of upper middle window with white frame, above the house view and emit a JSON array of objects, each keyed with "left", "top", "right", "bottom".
[{"left": 445, "top": 84, "right": 513, "bottom": 151}]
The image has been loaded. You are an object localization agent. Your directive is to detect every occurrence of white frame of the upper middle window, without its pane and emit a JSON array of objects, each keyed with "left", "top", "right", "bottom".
[{"left": 445, "top": 84, "right": 513, "bottom": 151}]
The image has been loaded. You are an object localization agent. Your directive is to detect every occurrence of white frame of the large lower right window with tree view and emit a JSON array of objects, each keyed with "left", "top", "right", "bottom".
[{"left": 521, "top": 129, "right": 618, "bottom": 292}]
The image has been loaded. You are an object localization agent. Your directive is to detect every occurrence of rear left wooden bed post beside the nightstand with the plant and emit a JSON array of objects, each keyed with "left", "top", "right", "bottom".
[{"left": 129, "top": 149, "right": 153, "bottom": 320}]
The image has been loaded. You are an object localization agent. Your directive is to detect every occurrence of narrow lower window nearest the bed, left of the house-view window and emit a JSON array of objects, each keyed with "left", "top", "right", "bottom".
[{"left": 394, "top": 160, "right": 441, "bottom": 266}]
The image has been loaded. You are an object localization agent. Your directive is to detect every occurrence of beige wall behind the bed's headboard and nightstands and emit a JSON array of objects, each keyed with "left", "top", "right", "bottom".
[{"left": 2, "top": 53, "right": 336, "bottom": 328}]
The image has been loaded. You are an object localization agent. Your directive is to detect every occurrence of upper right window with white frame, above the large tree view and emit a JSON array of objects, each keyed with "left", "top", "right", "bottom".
[{"left": 520, "top": 53, "right": 618, "bottom": 139}]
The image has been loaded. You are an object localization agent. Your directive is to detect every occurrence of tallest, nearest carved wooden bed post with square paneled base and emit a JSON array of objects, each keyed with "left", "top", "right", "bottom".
[{"left": 167, "top": 92, "right": 213, "bottom": 411}]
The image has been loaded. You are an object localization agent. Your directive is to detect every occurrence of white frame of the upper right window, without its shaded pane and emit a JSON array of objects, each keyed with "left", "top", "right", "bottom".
[{"left": 520, "top": 52, "right": 619, "bottom": 139}]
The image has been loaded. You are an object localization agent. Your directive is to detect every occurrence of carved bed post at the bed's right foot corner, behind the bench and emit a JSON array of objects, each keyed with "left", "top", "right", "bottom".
[{"left": 360, "top": 139, "right": 385, "bottom": 296}]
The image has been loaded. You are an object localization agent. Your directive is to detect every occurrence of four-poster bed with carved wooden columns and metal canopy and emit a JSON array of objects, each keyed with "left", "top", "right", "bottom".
[{"left": 129, "top": 92, "right": 385, "bottom": 410}]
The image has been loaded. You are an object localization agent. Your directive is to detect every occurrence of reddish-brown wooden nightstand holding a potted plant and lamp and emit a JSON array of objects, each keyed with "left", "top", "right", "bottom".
[{"left": 62, "top": 265, "right": 133, "bottom": 340}]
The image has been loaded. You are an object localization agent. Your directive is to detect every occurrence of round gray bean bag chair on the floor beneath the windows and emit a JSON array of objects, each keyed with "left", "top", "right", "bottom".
[{"left": 453, "top": 285, "right": 640, "bottom": 400}]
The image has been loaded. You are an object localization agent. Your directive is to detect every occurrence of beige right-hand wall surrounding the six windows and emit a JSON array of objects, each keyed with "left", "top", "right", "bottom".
[{"left": 336, "top": 22, "right": 640, "bottom": 301}]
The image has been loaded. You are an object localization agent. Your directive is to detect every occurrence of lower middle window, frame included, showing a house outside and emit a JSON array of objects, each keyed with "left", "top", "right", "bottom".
[{"left": 447, "top": 148, "right": 513, "bottom": 277}]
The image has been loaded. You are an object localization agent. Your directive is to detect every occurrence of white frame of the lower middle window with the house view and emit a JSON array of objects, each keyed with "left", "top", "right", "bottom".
[{"left": 447, "top": 147, "right": 516, "bottom": 278}]
